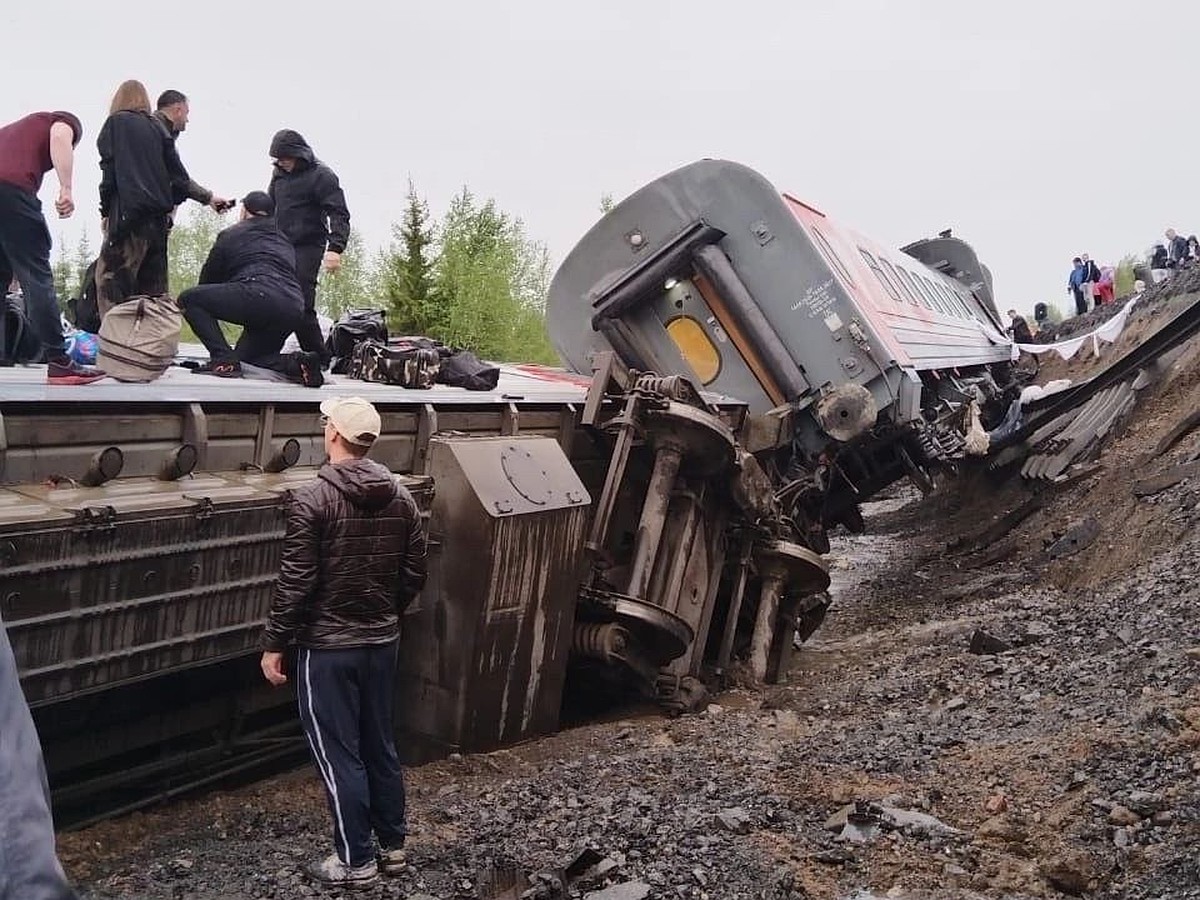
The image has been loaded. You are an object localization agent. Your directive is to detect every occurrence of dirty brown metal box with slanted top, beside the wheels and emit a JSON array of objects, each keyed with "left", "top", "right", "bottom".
[{"left": 397, "top": 437, "right": 590, "bottom": 762}]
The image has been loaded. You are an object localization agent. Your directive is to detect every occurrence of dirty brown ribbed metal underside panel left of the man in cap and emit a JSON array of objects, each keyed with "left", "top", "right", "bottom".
[{"left": 0, "top": 468, "right": 428, "bottom": 704}]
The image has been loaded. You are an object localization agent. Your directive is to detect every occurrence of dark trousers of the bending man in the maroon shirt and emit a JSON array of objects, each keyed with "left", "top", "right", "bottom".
[{"left": 0, "top": 182, "right": 66, "bottom": 359}]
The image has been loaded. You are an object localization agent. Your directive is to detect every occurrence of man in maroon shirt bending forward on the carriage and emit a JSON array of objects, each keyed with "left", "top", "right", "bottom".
[{"left": 0, "top": 112, "right": 104, "bottom": 384}]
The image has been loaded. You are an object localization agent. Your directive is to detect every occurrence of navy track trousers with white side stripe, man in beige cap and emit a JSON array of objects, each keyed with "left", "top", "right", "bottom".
[{"left": 295, "top": 641, "right": 406, "bottom": 866}]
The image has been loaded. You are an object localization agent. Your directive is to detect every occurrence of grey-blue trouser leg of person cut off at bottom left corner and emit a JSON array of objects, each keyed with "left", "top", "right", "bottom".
[{"left": 0, "top": 609, "right": 76, "bottom": 900}]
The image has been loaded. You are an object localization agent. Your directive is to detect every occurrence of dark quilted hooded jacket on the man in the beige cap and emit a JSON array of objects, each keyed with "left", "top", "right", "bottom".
[{"left": 262, "top": 460, "right": 425, "bottom": 652}]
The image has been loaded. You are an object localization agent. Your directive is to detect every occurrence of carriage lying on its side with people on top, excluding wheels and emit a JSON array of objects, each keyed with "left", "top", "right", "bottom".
[{"left": 0, "top": 368, "right": 590, "bottom": 816}]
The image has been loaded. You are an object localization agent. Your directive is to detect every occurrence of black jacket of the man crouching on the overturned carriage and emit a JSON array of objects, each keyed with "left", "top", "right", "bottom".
[{"left": 200, "top": 216, "right": 304, "bottom": 316}]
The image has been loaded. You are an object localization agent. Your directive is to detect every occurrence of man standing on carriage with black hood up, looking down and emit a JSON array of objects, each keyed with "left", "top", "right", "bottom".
[{"left": 266, "top": 128, "right": 350, "bottom": 365}]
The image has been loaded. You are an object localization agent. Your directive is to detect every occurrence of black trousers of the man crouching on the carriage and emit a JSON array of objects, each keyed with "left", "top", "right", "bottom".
[{"left": 179, "top": 281, "right": 298, "bottom": 368}]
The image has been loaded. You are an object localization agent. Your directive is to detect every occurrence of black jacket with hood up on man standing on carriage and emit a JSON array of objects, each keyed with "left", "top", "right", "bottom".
[{"left": 266, "top": 128, "right": 350, "bottom": 253}]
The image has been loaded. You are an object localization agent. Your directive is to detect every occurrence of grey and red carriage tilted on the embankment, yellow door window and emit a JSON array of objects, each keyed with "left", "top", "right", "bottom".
[{"left": 548, "top": 160, "right": 1015, "bottom": 551}]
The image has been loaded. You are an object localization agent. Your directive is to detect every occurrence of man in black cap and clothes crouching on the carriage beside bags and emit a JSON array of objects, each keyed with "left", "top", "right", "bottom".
[{"left": 179, "top": 191, "right": 323, "bottom": 386}]
